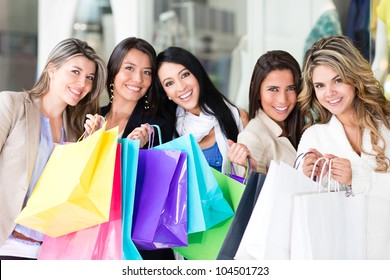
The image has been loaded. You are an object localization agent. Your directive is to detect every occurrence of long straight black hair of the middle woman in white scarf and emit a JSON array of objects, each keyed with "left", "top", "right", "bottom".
[{"left": 155, "top": 47, "right": 239, "bottom": 142}]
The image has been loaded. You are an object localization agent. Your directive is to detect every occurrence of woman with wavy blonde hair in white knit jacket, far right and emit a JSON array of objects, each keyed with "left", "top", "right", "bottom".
[{"left": 298, "top": 36, "right": 390, "bottom": 259}]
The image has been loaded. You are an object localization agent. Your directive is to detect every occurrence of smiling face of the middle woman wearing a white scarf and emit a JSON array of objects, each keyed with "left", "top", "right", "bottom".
[{"left": 157, "top": 62, "right": 201, "bottom": 115}]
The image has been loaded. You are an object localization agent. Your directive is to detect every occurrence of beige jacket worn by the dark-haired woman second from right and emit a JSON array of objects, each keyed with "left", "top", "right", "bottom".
[{"left": 237, "top": 109, "right": 296, "bottom": 175}]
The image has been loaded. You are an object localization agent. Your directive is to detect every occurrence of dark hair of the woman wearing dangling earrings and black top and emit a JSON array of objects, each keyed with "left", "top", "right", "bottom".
[{"left": 106, "top": 37, "right": 157, "bottom": 116}]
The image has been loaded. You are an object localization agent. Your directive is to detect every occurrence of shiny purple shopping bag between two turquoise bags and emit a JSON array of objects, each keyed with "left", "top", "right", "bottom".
[{"left": 132, "top": 150, "right": 188, "bottom": 250}]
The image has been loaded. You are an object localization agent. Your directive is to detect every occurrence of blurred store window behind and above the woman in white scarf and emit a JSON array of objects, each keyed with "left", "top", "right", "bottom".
[{"left": 152, "top": 0, "right": 246, "bottom": 107}]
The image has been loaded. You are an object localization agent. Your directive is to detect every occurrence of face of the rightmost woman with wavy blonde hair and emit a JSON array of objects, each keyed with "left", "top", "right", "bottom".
[{"left": 313, "top": 65, "right": 355, "bottom": 117}]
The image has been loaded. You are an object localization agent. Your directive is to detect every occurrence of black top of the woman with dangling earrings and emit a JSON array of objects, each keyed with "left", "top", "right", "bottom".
[{"left": 100, "top": 102, "right": 175, "bottom": 149}]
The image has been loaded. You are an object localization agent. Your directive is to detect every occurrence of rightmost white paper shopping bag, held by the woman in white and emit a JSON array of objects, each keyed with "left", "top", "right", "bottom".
[{"left": 291, "top": 191, "right": 366, "bottom": 260}]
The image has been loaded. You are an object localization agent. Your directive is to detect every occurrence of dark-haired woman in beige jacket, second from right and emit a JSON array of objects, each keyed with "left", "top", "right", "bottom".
[{"left": 228, "top": 50, "right": 304, "bottom": 175}]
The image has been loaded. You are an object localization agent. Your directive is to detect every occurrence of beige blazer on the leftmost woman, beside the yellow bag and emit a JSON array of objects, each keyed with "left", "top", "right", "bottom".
[{"left": 0, "top": 91, "right": 41, "bottom": 244}]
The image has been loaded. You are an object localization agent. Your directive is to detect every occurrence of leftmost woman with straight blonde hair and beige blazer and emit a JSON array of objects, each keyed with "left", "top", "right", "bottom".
[{"left": 0, "top": 38, "right": 106, "bottom": 260}]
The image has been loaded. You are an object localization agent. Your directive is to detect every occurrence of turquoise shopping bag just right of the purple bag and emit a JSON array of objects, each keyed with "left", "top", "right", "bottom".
[{"left": 153, "top": 134, "right": 234, "bottom": 233}]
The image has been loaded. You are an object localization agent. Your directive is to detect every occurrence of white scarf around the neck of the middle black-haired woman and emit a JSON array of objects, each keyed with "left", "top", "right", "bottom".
[{"left": 176, "top": 106, "right": 219, "bottom": 143}]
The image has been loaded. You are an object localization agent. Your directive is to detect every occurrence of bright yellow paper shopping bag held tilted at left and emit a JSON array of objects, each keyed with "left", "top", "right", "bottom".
[{"left": 16, "top": 125, "right": 118, "bottom": 237}]
